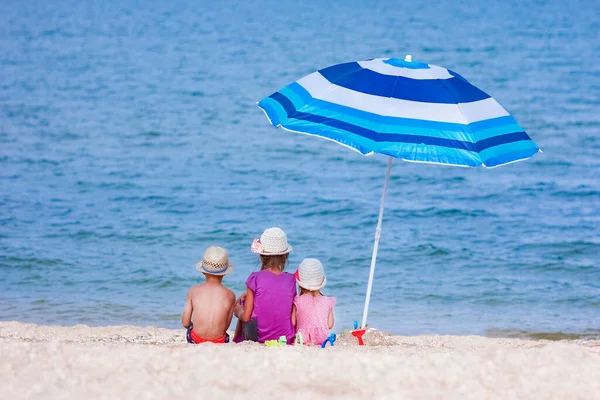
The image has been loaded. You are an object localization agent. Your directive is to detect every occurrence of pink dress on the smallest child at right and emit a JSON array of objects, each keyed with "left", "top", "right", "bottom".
[{"left": 294, "top": 294, "right": 335, "bottom": 345}]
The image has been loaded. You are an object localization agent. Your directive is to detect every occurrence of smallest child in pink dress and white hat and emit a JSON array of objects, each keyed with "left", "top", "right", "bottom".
[{"left": 292, "top": 258, "right": 335, "bottom": 345}]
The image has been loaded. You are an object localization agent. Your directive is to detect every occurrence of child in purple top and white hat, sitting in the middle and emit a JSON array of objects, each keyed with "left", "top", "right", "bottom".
[{"left": 233, "top": 228, "right": 296, "bottom": 343}]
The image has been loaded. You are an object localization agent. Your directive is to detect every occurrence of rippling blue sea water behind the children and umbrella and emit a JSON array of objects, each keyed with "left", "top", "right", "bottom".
[{"left": 0, "top": 0, "right": 600, "bottom": 337}]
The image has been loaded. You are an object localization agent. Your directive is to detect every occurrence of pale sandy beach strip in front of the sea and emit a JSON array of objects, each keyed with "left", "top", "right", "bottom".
[{"left": 0, "top": 322, "right": 600, "bottom": 399}]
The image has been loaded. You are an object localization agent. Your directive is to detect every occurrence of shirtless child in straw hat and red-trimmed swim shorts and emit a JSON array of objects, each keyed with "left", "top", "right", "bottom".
[{"left": 181, "top": 246, "right": 235, "bottom": 343}]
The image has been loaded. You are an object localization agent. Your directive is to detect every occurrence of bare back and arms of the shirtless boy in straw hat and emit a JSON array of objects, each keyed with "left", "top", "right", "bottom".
[{"left": 181, "top": 275, "right": 235, "bottom": 340}]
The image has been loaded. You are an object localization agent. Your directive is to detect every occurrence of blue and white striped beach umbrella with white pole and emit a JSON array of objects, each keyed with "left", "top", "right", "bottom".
[{"left": 258, "top": 55, "right": 540, "bottom": 327}]
